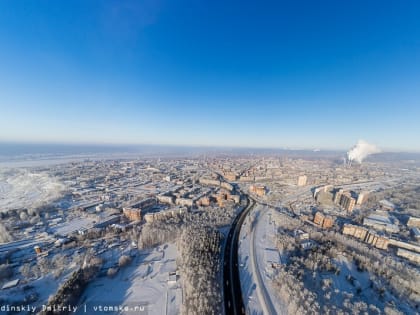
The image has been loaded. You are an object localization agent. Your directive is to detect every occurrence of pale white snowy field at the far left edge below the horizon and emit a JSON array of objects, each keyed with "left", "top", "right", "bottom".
[{"left": 0, "top": 169, "right": 65, "bottom": 211}]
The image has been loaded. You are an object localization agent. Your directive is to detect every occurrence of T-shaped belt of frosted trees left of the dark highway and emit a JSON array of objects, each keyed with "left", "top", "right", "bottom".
[{"left": 130, "top": 202, "right": 241, "bottom": 314}]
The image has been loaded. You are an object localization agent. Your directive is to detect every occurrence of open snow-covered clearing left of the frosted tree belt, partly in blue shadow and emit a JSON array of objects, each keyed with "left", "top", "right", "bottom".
[{"left": 79, "top": 243, "right": 182, "bottom": 314}]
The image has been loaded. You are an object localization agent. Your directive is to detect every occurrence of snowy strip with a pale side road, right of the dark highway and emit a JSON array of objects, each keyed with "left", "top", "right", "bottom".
[{"left": 239, "top": 206, "right": 287, "bottom": 314}]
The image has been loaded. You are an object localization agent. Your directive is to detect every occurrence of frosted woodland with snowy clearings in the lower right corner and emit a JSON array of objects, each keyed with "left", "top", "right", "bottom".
[{"left": 274, "top": 212, "right": 420, "bottom": 314}]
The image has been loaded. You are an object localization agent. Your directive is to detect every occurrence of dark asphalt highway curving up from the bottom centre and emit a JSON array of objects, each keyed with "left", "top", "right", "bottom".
[{"left": 223, "top": 195, "right": 255, "bottom": 315}]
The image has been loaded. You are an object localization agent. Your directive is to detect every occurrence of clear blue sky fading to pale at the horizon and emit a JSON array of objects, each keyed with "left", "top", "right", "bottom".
[{"left": 0, "top": 0, "right": 420, "bottom": 151}]
